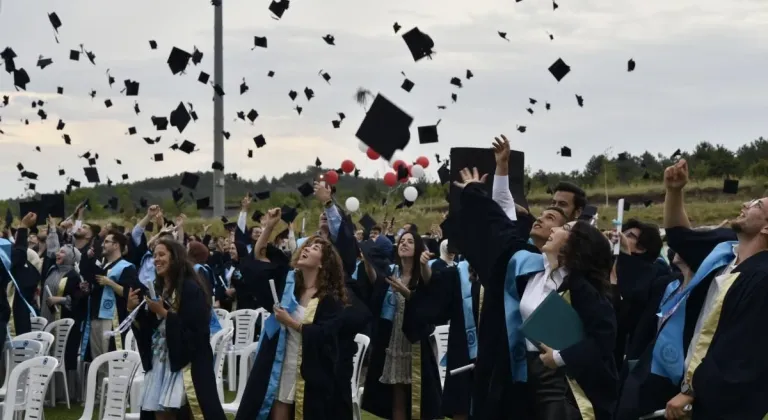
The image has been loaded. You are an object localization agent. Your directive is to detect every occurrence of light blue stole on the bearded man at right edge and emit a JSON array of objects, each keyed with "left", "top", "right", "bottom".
[{"left": 651, "top": 241, "right": 737, "bottom": 385}]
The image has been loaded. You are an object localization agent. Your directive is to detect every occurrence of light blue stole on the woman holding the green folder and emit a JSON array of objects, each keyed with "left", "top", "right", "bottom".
[{"left": 504, "top": 250, "right": 544, "bottom": 382}]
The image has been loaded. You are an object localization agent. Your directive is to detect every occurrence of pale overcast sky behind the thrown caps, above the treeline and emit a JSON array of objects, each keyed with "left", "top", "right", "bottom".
[{"left": 0, "top": 0, "right": 768, "bottom": 198}]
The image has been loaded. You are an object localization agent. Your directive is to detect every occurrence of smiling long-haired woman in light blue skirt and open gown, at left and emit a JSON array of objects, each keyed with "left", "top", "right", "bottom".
[{"left": 127, "top": 238, "right": 226, "bottom": 420}]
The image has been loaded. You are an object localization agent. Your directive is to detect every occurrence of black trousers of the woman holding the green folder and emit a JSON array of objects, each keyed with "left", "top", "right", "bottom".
[{"left": 526, "top": 352, "right": 581, "bottom": 420}]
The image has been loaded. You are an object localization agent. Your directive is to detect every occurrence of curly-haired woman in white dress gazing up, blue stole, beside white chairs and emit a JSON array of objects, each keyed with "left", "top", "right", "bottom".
[{"left": 236, "top": 208, "right": 351, "bottom": 420}]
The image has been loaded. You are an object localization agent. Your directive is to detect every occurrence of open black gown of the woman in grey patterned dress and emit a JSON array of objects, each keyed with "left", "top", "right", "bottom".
[{"left": 361, "top": 273, "right": 442, "bottom": 420}]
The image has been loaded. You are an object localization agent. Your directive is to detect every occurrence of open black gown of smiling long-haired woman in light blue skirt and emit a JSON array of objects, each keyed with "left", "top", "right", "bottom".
[{"left": 132, "top": 278, "right": 226, "bottom": 420}]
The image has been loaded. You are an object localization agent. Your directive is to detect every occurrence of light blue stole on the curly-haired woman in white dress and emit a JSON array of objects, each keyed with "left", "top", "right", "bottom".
[{"left": 256, "top": 270, "right": 299, "bottom": 420}]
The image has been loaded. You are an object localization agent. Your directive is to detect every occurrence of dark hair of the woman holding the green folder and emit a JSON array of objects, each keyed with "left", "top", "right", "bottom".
[{"left": 558, "top": 221, "right": 613, "bottom": 296}]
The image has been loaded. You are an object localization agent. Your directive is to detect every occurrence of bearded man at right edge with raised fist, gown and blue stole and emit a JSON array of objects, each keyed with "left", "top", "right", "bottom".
[{"left": 619, "top": 159, "right": 768, "bottom": 419}]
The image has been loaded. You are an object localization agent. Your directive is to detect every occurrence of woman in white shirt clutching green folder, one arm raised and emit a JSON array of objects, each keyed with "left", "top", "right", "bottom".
[{"left": 456, "top": 169, "right": 618, "bottom": 420}]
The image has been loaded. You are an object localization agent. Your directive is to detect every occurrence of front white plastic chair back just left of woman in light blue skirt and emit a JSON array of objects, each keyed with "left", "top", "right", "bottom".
[{"left": 80, "top": 350, "right": 141, "bottom": 420}]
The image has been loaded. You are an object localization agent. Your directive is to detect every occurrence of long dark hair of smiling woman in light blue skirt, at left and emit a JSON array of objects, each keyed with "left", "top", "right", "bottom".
[{"left": 155, "top": 238, "right": 211, "bottom": 311}]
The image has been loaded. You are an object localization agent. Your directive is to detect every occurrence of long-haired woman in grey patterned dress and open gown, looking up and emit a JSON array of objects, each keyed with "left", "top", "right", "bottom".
[{"left": 362, "top": 231, "right": 442, "bottom": 420}]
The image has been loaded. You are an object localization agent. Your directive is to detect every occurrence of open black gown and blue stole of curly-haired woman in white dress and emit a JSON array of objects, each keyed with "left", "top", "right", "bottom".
[{"left": 232, "top": 272, "right": 350, "bottom": 420}]
